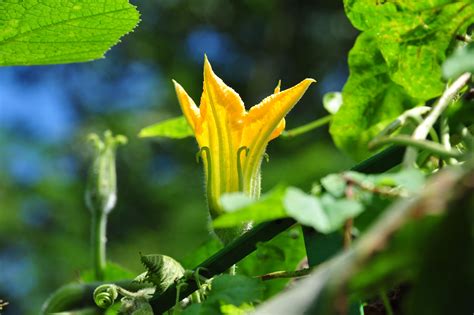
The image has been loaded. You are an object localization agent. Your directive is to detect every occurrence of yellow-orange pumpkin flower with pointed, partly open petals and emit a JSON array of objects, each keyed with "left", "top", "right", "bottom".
[{"left": 173, "top": 58, "right": 315, "bottom": 243}]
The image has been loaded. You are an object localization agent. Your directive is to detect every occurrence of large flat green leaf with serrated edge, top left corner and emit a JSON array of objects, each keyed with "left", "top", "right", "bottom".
[{"left": 0, "top": 0, "right": 139, "bottom": 66}]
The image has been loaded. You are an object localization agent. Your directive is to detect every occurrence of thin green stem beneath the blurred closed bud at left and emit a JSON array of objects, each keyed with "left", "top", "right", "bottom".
[{"left": 91, "top": 211, "right": 107, "bottom": 281}]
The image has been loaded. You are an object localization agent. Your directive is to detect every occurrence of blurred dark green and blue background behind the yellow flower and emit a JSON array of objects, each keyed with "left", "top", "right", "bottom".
[{"left": 0, "top": 0, "right": 357, "bottom": 314}]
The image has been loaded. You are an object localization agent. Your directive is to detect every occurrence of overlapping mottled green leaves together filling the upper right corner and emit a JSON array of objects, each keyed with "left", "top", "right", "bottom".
[{"left": 331, "top": 0, "right": 474, "bottom": 159}]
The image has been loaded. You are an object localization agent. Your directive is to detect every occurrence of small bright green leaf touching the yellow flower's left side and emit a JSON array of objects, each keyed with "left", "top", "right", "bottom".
[{"left": 138, "top": 116, "right": 194, "bottom": 139}]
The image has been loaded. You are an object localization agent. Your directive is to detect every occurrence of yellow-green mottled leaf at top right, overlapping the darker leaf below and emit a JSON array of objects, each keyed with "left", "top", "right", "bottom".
[{"left": 345, "top": 0, "right": 474, "bottom": 100}]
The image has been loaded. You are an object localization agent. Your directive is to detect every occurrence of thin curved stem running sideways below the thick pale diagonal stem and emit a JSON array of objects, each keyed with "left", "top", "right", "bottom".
[{"left": 370, "top": 135, "right": 464, "bottom": 158}]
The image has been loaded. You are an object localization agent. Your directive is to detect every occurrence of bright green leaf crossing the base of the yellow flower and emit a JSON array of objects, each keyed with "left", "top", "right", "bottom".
[{"left": 212, "top": 186, "right": 286, "bottom": 228}]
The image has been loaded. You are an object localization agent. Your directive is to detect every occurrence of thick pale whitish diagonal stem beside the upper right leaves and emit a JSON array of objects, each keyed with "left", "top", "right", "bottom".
[{"left": 403, "top": 72, "right": 471, "bottom": 167}]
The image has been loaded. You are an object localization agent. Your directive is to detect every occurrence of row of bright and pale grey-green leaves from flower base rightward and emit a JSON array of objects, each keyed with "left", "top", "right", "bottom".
[{"left": 213, "top": 169, "right": 425, "bottom": 234}]
